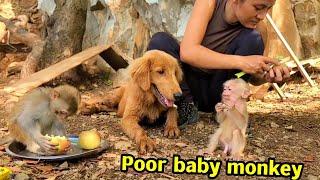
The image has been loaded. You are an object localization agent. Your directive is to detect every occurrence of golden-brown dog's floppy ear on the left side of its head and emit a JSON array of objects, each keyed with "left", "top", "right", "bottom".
[{"left": 130, "top": 56, "right": 151, "bottom": 91}]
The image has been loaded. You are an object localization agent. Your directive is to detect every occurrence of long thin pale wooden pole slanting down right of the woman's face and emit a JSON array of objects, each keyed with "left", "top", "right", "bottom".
[{"left": 267, "top": 13, "right": 315, "bottom": 87}]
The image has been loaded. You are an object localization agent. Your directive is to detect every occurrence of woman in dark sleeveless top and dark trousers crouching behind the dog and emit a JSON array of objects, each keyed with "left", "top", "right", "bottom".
[{"left": 148, "top": 0, "right": 290, "bottom": 123}]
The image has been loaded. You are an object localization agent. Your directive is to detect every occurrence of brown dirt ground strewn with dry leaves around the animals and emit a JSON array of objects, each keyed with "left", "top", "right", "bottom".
[{"left": 0, "top": 74, "right": 320, "bottom": 180}]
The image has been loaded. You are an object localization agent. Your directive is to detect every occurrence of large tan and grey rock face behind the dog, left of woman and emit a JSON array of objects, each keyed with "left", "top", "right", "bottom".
[{"left": 83, "top": 0, "right": 194, "bottom": 74}]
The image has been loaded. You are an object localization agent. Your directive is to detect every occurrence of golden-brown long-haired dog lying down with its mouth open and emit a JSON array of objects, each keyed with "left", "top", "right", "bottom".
[{"left": 84, "top": 50, "right": 182, "bottom": 154}]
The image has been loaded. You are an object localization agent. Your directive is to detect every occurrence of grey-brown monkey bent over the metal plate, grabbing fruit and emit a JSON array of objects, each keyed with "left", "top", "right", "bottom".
[{"left": 0, "top": 85, "right": 80, "bottom": 155}]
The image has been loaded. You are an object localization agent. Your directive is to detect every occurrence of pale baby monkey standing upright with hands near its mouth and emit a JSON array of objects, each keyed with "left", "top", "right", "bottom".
[{"left": 207, "top": 79, "right": 250, "bottom": 160}]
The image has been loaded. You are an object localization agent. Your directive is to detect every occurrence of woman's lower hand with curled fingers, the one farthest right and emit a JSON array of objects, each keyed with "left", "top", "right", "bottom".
[{"left": 265, "top": 65, "right": 291, "bottom": 83}]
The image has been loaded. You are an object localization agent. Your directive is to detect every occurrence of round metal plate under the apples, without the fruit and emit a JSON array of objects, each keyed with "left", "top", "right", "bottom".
[{"left": 6, "top": 137, "right": 108, "bottom": 161}]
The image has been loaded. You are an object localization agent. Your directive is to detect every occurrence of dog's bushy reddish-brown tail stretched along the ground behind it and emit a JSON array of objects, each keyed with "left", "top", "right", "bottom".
[{"left": 80, "top": 86, "right": 125, "bottom": 114}]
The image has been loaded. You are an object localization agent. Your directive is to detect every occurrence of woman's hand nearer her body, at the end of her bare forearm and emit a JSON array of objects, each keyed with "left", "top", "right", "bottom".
[{"left": 238, "top": 55, "right": 279, "bottom": 74}]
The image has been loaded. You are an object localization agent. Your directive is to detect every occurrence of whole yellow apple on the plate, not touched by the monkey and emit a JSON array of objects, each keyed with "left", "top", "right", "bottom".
[{"left": 79, "top": 130, "right": 101, "bottom": 150}]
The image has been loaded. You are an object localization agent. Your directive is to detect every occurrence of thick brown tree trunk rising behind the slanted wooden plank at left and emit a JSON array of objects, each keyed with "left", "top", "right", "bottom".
[{"left": 40, "top": 0, "right": 87, "bottom": 79}]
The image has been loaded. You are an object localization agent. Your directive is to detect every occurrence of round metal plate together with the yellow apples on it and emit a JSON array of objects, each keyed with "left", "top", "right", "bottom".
[{"left": 6, "top": 130, "right": 108, "bottom": 161}]
